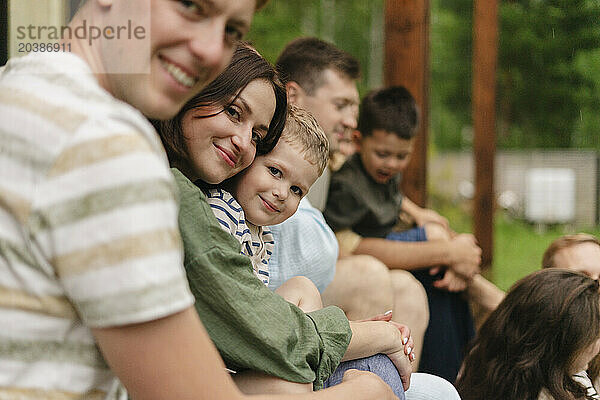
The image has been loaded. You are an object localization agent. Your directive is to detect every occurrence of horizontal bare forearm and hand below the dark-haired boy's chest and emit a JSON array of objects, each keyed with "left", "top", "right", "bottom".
[{"left": 354, "top": 234, "right": 481, "bottom": 278}]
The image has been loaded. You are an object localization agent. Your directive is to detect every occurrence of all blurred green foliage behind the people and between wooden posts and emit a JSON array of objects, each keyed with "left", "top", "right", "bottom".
[{"left": 249, "top": 0, "right": 600, "bottom": 150}]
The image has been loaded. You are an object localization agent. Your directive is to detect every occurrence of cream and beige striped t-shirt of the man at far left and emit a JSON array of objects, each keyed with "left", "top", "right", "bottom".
[{"left": 0, "top": 53, "right": 193, "bottom": 400}]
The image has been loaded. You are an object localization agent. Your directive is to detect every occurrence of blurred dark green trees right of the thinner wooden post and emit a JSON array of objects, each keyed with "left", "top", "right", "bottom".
[{"left": 498, "top": 0, "right": 600, "bottom": 147}]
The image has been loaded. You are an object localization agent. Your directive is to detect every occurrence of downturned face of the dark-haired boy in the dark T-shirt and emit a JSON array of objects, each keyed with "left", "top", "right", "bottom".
[{"left": 357, "top": 129, "right": 414, "bottom": 183}]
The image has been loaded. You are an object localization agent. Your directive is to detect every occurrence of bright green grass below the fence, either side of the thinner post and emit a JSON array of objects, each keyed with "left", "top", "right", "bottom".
[{"left": 430, "top": 196, "right": 600, "bottom": 290}]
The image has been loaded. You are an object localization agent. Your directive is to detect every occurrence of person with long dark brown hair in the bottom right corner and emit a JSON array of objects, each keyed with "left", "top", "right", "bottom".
[{"left": 456, "top": 268, "right": 600, "bottom": 400}]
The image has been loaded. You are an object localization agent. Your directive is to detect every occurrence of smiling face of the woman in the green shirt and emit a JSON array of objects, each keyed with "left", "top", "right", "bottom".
[{"left": 182, "top": 79, "right": 275, "bottom": 184}]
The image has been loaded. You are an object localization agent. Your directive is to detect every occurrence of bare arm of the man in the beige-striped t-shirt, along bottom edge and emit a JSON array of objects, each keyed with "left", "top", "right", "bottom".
[{"left": 92, "top": 307, "right": 396, "bottom": 400}]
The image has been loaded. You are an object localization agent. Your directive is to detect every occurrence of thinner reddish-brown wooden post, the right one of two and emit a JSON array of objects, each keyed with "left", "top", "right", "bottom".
[{"left": 473, "top": 0, "right": 498, "bottom": 268}]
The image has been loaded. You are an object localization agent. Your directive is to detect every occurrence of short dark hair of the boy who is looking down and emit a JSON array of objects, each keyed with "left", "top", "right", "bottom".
[{"left": 358, "top": 86, "right": 419, "bottom": 140}]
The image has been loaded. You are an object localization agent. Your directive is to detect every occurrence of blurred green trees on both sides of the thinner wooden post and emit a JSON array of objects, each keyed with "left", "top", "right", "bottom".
[{"left": 431, "top": 0, "right": 600, "bottom": 148}]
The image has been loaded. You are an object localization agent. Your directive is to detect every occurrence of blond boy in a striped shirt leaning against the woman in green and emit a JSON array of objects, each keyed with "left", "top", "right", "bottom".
[{"left": 208, "top": 105, "right": 329, "bottom": 312}]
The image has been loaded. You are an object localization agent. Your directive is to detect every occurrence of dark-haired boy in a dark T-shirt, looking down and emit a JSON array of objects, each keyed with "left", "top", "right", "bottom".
[{"left": 324, "top": 87, "right": 477, "bottom": 382}]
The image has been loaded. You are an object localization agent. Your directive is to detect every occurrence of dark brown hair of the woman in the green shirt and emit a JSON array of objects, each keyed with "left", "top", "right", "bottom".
[{"left": 152, "top": 44, "right": 287, "bottom": 172}]
